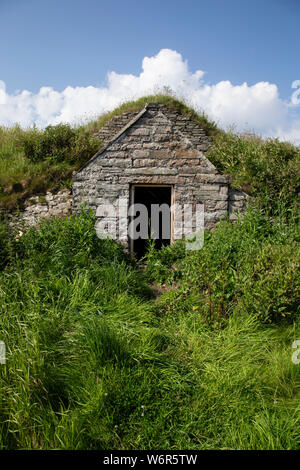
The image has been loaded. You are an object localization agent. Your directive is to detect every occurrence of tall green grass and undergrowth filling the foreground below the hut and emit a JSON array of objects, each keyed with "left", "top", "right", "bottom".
[{"left": 0, "top": 209, "right": 300, "bottom": 450}]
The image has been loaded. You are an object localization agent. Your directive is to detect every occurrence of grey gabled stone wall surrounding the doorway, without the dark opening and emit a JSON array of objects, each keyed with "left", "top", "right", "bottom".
[{"left": 73, "top": 104, "right": 246, "bottom": 248}]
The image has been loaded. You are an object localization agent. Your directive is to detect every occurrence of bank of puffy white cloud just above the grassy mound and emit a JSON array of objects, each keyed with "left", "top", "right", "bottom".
[{"left": 0, "top": 49, "right": 300, "bottom": 144}]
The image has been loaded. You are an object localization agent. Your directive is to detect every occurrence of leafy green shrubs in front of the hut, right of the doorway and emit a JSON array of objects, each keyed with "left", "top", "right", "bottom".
[{"left": 154, "top": 207, "right": 300, "bottom": 322}]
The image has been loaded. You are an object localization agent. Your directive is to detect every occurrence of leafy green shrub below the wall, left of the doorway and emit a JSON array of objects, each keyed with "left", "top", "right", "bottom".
[{"left": 15, "top": 210, "right": 127, "bottom": 275}]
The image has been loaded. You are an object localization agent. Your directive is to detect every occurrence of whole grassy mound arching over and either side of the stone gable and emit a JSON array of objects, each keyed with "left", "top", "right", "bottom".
[{"left": 0, "top": 95, "right": 300, "bottom": 212}]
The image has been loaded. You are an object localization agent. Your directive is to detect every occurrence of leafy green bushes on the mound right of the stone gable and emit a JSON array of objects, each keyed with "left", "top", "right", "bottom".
[{"left": 208, "top": 132, "right": 300, "bottom": 212}]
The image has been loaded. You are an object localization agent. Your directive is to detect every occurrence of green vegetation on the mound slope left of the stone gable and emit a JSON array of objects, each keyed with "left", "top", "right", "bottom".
[{"left": 0, "top": 124, "right": 99, "bottom": 212}]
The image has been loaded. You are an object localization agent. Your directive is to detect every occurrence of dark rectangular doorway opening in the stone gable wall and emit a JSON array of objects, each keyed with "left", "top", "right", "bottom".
[{"left": 130, "top": 185, "right": 172, "bottom": 258}]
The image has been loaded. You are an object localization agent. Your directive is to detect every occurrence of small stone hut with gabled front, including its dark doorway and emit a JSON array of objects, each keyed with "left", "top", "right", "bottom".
[{"left": 72, "top": 103, "right": 247, "bottom": 251}]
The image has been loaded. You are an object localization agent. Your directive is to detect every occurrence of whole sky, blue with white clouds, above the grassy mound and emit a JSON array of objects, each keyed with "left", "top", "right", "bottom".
[{"left": 0, "top": 0, "right": 300, "bottom": 142}]
